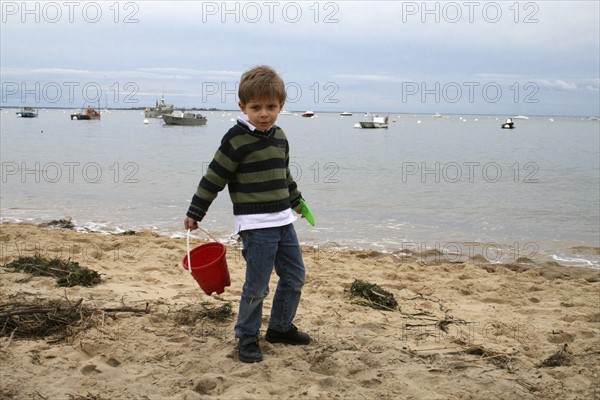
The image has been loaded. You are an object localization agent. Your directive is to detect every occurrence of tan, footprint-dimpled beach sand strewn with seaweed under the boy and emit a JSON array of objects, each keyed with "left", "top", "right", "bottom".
[{"left": 0, "top": 224, "right": 600, "bottom": 400}]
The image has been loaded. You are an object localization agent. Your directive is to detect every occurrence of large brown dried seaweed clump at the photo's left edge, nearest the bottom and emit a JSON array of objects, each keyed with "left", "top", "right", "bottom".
[{"left": 0, "top": 299, "right": 94, "bottom": 340}]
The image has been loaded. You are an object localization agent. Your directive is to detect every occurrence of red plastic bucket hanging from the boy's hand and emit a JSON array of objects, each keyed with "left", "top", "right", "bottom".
[{"left": 182, "top": 243, "right": 231, "bottom": 296}]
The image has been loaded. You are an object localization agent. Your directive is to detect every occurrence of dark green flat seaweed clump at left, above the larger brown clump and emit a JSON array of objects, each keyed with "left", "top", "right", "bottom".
[{"left": 3, "top": 254, "right": 100, "bottom": 287}]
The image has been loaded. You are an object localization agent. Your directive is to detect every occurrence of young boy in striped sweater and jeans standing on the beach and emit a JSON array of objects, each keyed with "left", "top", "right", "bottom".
[{"left": 184, "top": 65, "right": 311, "bottom": 362}]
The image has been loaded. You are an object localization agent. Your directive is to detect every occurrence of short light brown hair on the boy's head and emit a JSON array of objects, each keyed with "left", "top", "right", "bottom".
[{"left": 238, "top": 65, "right": 287, "bottom": 104}]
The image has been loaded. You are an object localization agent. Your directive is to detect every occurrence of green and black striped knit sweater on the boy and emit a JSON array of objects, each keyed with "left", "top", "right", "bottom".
[{"left": 187, "top": 122, "right": 302, "bottom": 221}]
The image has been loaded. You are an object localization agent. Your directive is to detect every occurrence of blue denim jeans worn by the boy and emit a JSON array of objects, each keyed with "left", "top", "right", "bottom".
[{"left": 235, "top": 224, "right": 305, "bottom": 338}]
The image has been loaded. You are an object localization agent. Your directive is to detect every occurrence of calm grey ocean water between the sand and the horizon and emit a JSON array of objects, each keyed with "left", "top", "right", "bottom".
[{"left": 0, "top": 109, "right": 600, "bottom": 268}]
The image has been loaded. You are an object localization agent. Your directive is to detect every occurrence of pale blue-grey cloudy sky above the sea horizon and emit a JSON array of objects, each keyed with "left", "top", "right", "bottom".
[{"left": 0, "top": 0, "right": 600, "bottom": 116}]
